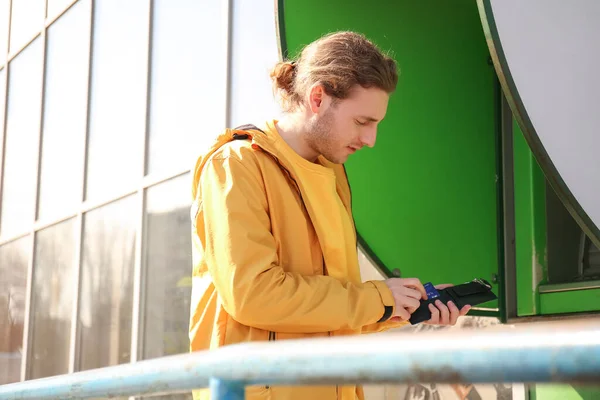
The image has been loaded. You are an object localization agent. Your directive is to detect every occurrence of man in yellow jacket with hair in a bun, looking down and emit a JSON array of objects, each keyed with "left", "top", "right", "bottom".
[{"left": 190, "top": 32, "right": 468, "bottom": 400}]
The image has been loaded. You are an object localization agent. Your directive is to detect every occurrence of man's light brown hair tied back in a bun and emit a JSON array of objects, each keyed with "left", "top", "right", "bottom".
[{"left": 271, "top": 32, "right": 398, "bottom": 111}]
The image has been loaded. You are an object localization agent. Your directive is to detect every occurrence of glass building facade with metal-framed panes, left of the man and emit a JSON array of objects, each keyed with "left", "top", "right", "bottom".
[{"left": 0, "top": 0, "right": 279, "bottom": 394}]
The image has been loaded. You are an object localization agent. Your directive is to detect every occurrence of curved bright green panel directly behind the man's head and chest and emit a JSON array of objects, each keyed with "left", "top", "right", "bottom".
[{"left": 279, "top": 0, "right": 499, "bottom": 307}]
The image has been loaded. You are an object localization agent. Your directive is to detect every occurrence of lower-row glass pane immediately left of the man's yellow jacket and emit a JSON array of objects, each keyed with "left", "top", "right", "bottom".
[{"left": 140, "top": 175, "right": 192, "bottom": 359}]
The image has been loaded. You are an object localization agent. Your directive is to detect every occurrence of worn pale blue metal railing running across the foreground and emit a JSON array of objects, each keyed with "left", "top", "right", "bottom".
[{"left": 0, "top": 320, "right": 600, "bottom": 400}]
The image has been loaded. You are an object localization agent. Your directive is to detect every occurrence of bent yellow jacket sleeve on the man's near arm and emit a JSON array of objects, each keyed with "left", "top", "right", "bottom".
[{"left": 196, "top": 156, "right": 394, "bottom": 333}]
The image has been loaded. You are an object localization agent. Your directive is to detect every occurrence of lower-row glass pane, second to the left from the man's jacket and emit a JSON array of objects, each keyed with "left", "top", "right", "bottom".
[{"left": 78, "top": 196, "right": 136, "bottom": 370}]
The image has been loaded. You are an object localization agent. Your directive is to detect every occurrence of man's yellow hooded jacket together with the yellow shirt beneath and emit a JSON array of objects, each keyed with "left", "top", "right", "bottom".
[{"left": 190, "top": 121, "right": 403, "bottom": 400}]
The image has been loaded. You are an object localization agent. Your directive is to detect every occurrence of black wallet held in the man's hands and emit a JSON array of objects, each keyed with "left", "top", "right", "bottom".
[{"left": 409, "top": 279, "right": 498, "bottom": 325}]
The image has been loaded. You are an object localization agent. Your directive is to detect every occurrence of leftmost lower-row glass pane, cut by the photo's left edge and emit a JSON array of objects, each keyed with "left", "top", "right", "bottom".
[{"left": 0, "top": 237, "right": 31, "bottom": 385}]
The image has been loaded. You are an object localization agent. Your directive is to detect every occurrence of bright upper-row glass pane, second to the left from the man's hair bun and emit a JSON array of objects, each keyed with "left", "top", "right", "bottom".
[{"left": 148, "top": 0, "right": 227, "bottom": 173}]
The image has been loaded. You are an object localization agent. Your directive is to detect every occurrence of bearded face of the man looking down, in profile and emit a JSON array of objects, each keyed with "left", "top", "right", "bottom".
[{"left": 306, "top": 86, "right": 389, "bottom": 164}]
